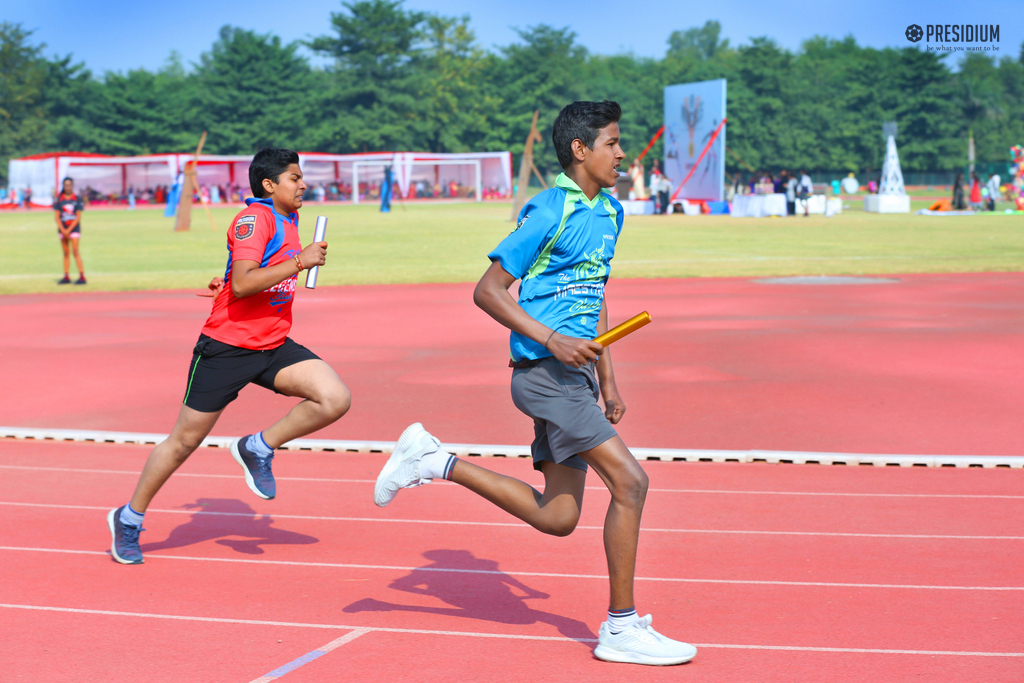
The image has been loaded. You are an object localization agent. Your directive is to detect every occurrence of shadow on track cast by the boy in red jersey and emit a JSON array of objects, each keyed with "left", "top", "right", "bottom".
[{"left": 141, "top": 498, "right": 319, "bottom": 555}]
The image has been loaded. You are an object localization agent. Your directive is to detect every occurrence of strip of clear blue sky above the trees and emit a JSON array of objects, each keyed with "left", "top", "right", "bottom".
[{"left": 8, "top": 0, "right": 1024, "bottom": 74}]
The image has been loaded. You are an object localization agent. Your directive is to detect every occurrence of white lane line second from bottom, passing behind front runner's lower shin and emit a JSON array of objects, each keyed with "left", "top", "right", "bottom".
[{"left": 0, "top": 546, "right": 1024, "bottom": 592}]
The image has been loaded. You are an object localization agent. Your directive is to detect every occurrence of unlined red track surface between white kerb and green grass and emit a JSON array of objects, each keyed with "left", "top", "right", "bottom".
[{"left": 0, "top": 273, "right": 1024, "bottom": 456}]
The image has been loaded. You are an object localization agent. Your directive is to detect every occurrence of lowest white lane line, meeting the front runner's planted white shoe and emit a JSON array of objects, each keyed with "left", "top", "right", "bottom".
[{"left": 0, "top": 603, "right": 1024, "bottom": 657}]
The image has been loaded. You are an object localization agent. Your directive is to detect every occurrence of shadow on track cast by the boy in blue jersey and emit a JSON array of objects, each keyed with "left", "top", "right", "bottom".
[{"left": 342, "top": 550, "right": 597, "bottom": 648}]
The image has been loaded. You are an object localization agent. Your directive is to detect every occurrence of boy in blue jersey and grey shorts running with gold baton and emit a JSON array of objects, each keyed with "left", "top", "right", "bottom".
[{"left": 374, "top": 101, "right": 696, "bottom": 665}]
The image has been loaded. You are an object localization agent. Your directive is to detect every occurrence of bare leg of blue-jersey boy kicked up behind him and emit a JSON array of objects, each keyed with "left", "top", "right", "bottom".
[{"left": 452, "top": 460, "right": 587, "bottom": 536}]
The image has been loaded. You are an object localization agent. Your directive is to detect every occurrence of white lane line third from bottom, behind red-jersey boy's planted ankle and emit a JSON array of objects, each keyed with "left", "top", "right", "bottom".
[{"left": 0, "top": 501, "right": 1024, "bottom": 541}]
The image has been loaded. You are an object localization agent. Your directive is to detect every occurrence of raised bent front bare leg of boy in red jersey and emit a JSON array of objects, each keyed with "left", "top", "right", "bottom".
[{"left": 263, "top": 359, "right": 352, "bottom": 449}]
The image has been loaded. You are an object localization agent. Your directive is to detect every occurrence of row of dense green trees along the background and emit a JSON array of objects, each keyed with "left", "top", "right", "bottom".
[{"left": 0, "top": 0, "right": 1024, "bottom": 180}]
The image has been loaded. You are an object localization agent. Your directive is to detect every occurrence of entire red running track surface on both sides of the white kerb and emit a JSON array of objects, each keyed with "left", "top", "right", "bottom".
[{"left": 0, "top": 274, "right": 1024, "bottom": 683}]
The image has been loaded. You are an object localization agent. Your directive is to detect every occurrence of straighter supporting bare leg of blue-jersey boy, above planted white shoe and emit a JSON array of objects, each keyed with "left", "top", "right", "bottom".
[{"left": 580, "top": 436, "right": 648, "bottom": 609}]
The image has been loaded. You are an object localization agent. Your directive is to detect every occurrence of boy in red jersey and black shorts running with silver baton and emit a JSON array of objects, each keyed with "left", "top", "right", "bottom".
[{"left": 106, "top": 148, "right": 351, "bottom": 564}]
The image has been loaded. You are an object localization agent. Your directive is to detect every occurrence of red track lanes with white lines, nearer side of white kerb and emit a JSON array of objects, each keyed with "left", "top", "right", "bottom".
[{"left": 0, "top": 440, "right": 1024, "bottom": 682}]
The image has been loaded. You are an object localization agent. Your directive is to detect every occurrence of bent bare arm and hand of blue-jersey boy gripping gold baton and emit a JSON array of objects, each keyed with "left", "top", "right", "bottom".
[{"left": 473, "top": 261, "right": 604, "bottom": 368}]
